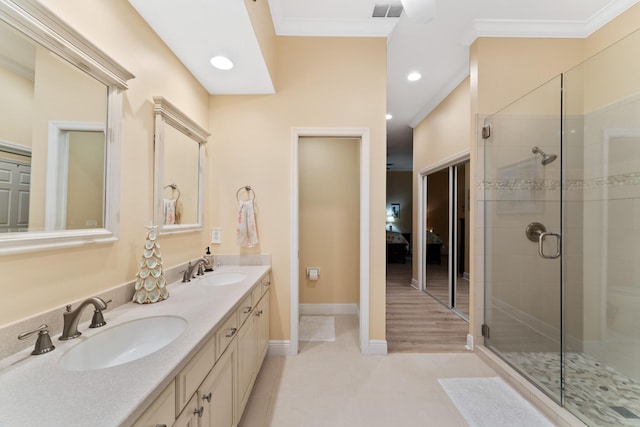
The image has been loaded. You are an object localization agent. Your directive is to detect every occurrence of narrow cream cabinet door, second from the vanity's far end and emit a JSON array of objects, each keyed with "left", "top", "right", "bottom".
[{"left": 237, "top": 316, "right": 258, "bottom": 414}]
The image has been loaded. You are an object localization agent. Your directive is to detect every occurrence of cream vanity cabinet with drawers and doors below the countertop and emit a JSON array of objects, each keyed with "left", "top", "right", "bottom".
[{"left": 134, "top": 275, "right": 270, "bottom": 427}]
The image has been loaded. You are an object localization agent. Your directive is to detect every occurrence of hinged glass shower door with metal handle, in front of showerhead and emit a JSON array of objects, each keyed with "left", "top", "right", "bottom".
[{"left": 481, "top": 76, "right": 562, "bottom": 402}]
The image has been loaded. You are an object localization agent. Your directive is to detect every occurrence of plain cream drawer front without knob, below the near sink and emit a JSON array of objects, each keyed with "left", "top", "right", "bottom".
[{"left": 176, "top": 339, "right": 216, "bottom": 414}]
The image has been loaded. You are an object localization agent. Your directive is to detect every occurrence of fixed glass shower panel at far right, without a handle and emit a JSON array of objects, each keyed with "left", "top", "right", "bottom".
[{"left": 563, "top": 28, "right": 640, "bottom": 426}]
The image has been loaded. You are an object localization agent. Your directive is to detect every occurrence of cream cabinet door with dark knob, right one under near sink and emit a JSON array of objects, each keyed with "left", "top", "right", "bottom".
[{"left": 198, "top": 343, "right": 236, "bottom": 427}]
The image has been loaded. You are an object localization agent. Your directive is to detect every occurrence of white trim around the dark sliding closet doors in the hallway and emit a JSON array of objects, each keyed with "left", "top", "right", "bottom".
[{"left": 416, "top": 149, "right": 471, "bottom": 304}]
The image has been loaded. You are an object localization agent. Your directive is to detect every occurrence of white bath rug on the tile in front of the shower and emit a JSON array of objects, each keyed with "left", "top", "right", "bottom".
[{"left": 438, "top": 377, "right": 553, "bottom": 427}]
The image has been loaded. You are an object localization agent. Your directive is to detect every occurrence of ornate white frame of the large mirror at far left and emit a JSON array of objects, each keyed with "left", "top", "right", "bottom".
[{"left": 0, "top": 0, "right": 134, "bottom": 255}]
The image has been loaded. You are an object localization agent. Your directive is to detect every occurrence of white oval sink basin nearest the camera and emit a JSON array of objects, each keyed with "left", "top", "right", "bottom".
[{"left": 59, "top": 316, "right": 187, "bottom": 371}]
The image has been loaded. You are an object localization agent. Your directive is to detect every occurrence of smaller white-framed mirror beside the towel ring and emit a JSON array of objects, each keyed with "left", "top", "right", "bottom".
[{"left": 153, "top": 96, "right": 209, "bottom": 234}]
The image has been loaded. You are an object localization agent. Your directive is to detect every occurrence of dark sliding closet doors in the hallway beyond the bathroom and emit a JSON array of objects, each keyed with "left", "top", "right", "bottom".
[{"left": 419, "top": 155, "right": 470, "bottom": 322}]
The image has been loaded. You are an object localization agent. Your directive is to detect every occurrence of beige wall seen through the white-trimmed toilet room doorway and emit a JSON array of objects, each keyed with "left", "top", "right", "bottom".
[{"left": 298, "top": 138, "right": 360, "bottom": 304}]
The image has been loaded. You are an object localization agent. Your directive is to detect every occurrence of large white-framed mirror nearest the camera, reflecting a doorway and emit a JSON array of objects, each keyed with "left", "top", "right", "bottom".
[{"left": 0, "top": 0, "right": 133, "bottom": 255}]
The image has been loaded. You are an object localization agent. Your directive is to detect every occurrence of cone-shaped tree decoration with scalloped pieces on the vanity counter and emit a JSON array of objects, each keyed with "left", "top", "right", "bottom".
[{"left": 133, "top": 225, "right": 169, "bottom": 304}]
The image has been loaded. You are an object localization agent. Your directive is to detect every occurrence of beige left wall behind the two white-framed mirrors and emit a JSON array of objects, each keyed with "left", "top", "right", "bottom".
[{"left": 0, "top": 0, "right": 211, "bottom": 325}]
